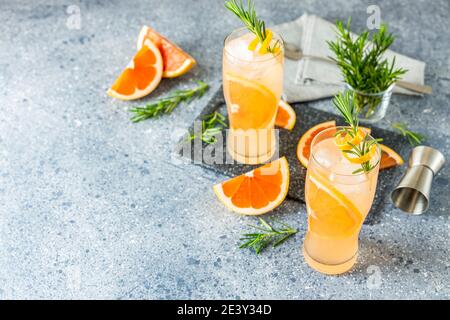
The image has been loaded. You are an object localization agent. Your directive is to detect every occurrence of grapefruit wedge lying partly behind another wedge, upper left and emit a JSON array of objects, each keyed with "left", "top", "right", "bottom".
[{"left": 137, "top": 26, "right": 196, "bottom": 78}]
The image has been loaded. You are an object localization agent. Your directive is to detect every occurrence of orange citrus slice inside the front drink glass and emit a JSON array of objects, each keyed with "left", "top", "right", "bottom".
[{"left": 305, "top": 172, "right": 364, "bottom": 238}]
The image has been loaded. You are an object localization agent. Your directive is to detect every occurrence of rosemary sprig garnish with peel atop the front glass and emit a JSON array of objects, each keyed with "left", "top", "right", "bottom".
[{"left": 333, "top": 91, "right": 382, "bottom": 174}]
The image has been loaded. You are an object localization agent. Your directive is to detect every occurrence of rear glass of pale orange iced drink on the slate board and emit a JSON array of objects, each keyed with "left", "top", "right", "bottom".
[{"left": 223, "top": 28, "right": 284, "bottom": 164}]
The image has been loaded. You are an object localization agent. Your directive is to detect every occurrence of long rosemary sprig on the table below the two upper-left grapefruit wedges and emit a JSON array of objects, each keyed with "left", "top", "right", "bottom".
[{"left": 130, "top": 81, "right": 208, "bottom": 122}]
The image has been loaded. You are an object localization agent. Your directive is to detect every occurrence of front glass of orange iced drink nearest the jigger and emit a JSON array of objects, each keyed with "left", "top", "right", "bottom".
[{"left": 303, "top": 128, "right": 381, "bottom": 274}]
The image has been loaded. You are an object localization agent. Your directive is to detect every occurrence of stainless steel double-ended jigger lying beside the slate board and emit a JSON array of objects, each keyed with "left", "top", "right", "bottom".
[{"left": 391, "top": 146, "right": 445, "bottom": 215}]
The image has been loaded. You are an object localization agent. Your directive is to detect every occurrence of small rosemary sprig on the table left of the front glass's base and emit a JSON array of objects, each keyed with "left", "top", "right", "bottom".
[{"left": 239, "top": 218, "right": 298, "bottom": 254}]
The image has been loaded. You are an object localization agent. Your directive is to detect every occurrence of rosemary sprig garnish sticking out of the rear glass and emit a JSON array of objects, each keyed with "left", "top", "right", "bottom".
[{"left": 225, "top": 0, "right": 280, "bottom": 53}]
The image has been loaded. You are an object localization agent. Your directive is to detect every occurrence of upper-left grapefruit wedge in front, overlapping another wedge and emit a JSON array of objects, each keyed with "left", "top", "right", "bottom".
[{"left": 107, "top": 40, "right": 163, "bottom": 100}]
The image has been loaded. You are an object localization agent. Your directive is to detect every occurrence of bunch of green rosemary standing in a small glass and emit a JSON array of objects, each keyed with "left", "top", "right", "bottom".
[{"left": 327, "top": 17, "right": 407, "bottom": 118}]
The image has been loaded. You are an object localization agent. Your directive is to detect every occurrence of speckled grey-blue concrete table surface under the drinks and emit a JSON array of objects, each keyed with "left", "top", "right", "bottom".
[{"left": 0, "top": 0, "right": 450, "bottom": 299}]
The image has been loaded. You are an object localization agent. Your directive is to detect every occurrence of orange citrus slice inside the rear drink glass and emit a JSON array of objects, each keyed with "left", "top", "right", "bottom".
[{"left": 224, "top": 74, "right": 278, "bottom": 130}]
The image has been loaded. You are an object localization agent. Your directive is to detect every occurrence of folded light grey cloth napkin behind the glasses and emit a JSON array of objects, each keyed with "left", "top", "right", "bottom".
[{"left": 272, "top": 14, "right": 425, "bottom": 102}]
